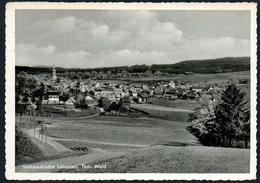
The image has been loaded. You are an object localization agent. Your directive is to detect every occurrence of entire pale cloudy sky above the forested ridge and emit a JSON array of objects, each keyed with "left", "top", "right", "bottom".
[{"left": 15, "top": 10, "right": 250, "bottom": 68}]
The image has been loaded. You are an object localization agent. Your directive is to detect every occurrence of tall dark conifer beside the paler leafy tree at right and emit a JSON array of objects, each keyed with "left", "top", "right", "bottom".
[{"left": 215, "top": 82, "right": 250, "bottom": 147}]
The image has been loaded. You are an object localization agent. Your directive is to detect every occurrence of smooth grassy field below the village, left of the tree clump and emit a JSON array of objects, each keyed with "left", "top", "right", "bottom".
[{"left": 48, "top": 116, "right": 198, "bottom": 149}]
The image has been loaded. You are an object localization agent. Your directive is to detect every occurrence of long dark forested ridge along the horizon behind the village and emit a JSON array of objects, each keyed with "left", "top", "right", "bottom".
[{"left": 15, "top": 57, "right": 250, "bottom": 74}]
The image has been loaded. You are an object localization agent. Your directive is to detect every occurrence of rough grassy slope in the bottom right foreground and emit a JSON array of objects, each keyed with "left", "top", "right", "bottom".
[{"left": 71, "top": 146, "right": 250, "bottom": 173}]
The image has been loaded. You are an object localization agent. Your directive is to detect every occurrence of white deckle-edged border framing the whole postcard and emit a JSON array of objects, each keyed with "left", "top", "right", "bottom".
[{"left": 5, "top": 2, "right": 257, "bottom": 180}]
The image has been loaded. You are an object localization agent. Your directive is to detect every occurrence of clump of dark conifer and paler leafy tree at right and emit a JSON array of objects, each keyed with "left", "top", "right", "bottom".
[{"left": 187, "top": 82, "right": 250, "bottom": 148}]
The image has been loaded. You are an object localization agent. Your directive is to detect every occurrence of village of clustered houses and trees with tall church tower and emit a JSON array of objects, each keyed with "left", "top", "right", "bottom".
[{"left": 16, "top": 66, "right": 247, "bottom": 115}]
